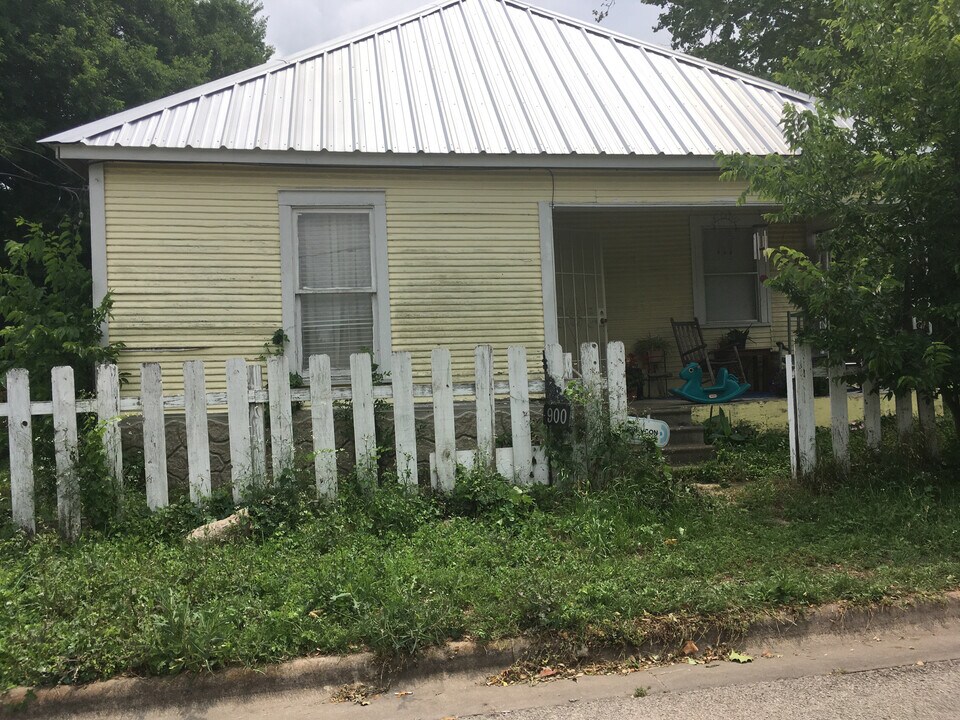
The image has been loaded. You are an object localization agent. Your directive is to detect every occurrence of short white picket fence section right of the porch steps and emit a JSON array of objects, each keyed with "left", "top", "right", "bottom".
[{"left": 786, "top": 344, "right": 939, "bottom": 477}]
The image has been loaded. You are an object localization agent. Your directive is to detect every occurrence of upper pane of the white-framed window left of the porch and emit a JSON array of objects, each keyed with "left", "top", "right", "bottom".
[{"left": 297, "top": 212, "right": 372, "bottom": 289}]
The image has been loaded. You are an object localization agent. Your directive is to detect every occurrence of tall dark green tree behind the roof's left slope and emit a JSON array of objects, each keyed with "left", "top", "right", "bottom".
[{"left": 0, "top": 0, "right": 272, "bottom": 238}]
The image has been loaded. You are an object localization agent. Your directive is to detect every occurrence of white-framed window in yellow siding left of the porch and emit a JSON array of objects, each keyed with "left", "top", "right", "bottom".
[{"left": 280, "top": 192, "right": 390, "bottom": 379}]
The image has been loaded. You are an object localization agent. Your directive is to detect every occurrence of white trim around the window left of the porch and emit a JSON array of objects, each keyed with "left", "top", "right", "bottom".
[{"left": 280, "top": 190, "right": 392, "bottom": 380}]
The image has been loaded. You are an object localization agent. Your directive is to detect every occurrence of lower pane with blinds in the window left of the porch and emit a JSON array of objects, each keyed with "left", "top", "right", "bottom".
[{"left": 300, "top": 293, "right": 373, "bottom": 372}]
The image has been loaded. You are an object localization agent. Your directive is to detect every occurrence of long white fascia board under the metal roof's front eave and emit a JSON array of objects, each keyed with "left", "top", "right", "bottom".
[{"left": 54, "top": 144, "right": 719, "bottom": 171}]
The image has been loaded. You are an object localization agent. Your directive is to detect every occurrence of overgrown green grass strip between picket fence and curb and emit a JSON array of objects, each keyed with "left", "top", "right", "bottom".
[{"left": 0, "top": 424, "right": 960, "bottom": 688}]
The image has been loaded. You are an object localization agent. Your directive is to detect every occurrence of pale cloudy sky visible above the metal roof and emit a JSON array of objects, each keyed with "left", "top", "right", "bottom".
[{"left": 262, "top": 0, "right": 670, "bottom": 57}]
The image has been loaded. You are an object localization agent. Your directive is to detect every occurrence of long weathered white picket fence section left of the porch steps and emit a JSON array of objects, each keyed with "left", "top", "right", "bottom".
[{"left": 0, "top": 342, "right": 627, "bottom": 537}]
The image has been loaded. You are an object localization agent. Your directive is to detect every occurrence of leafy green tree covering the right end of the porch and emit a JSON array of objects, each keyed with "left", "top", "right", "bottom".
[{"left": 722, "top": 0, "right": 960, "bottom": 434}]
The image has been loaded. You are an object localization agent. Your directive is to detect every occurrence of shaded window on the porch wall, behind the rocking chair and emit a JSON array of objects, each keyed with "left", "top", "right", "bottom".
[{"left": 692, "top": 218, "right": 769, "bottom": 326}]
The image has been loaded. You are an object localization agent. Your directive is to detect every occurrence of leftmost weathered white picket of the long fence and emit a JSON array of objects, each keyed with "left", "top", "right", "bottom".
[{"left": 7, "top": 369, "right": 37, "bottom": 535}]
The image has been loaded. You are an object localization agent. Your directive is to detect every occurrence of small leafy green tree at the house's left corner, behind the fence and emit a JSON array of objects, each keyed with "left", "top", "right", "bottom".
[{"left": 0, "top": 220, "right": 122, "bottom": 399}]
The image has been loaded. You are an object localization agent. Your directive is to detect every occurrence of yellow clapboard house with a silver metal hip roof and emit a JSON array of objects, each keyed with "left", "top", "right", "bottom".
[{"left": 42, "top": 0, "right": 812, "bottom": 391}]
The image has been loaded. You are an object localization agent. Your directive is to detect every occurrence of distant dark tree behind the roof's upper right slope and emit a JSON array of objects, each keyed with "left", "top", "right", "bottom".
[{"left": 593, "top": 0, "right": 834, "bottom": 79}]
